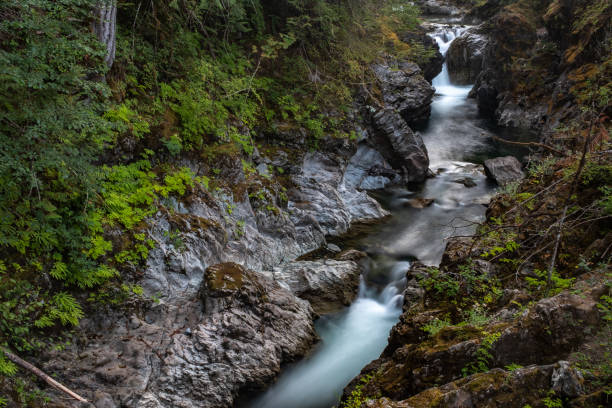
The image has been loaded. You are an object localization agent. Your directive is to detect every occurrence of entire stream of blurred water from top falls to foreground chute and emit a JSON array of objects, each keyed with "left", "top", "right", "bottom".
[{"left": 251, "top": 24, "right": 520, "bottom": 408}]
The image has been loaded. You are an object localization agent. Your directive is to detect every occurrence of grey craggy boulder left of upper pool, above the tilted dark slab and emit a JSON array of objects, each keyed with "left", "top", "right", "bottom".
[{"left": 372, "top": 62, "right": 435, "bottom": 125}]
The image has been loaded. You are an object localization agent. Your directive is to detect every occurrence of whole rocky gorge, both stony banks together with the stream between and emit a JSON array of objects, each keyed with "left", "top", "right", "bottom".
[{"left": 2, "top": 0, "right": 612, "bottom": 408}]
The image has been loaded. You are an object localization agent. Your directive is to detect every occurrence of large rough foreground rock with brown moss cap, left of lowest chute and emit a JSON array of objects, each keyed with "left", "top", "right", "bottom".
[{"left": 46, "top": 263, "right": 316, "bottom": 408}]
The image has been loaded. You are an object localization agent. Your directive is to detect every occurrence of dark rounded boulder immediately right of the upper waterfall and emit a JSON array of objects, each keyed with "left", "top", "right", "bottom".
[{"left": 446, "top": 28, "right": 487, "bottom": 85}]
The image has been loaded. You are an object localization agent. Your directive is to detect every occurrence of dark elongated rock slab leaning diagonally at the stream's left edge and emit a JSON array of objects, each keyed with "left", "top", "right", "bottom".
[{"left": 372, "top": 109, "right": 429, "bottom": 183}]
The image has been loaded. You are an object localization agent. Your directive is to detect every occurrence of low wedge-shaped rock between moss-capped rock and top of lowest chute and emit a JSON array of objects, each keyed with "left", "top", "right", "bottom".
[{"left": 265, "top": 260, "right": 361, "bottom": 314}]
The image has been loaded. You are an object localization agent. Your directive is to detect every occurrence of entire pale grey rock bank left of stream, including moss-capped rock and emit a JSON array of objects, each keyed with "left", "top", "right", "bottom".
[{"left": 39, "top": 140, "right": 387, "bottom": 408}]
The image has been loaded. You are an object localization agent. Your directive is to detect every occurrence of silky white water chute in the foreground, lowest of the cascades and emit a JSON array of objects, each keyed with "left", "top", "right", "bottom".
[{"left": 250, "top": 259, "right": 410, "bottom": 408}]
